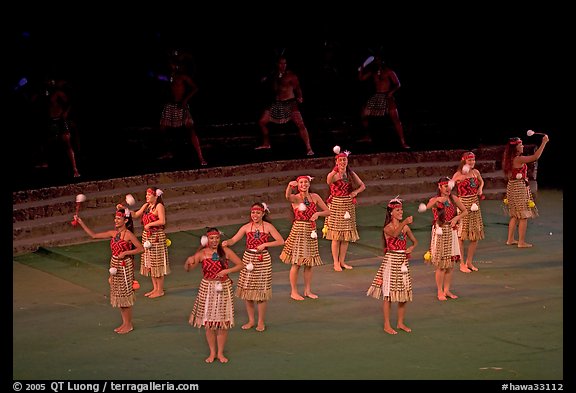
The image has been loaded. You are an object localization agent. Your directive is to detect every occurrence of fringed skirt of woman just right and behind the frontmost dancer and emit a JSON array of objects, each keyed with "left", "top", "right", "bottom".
[{"left": 236, "top": 250, "right": 272, "bottom": 302}]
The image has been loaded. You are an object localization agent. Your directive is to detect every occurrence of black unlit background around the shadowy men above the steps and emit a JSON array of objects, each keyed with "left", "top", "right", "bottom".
[{"left": 2, "top": 10, "right": 572, "bottom": 190}]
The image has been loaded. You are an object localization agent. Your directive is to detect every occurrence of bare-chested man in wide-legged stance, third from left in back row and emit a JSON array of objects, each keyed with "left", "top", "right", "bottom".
[{"left": 256, "top": 57, "right": 314, "bottom": 156}]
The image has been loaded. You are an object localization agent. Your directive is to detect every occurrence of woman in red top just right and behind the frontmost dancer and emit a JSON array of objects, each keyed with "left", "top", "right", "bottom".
[{"left": 222, "top": 202, "right": 284, "bottom": 332}]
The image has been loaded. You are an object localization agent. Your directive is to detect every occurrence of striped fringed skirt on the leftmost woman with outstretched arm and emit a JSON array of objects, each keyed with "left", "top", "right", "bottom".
[{"left": 110, "top": 255, "right": 136, "bottom": 307}]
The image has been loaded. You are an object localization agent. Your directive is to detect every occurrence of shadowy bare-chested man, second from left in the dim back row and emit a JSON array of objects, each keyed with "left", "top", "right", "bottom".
[{"left": 160, "top": 60, "right": 208, "bottom": 165}]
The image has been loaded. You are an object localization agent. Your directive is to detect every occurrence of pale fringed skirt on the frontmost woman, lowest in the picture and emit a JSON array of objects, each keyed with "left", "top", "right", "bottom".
[{"left": 188, "top": 278, "right": 234, "bottom": 330}]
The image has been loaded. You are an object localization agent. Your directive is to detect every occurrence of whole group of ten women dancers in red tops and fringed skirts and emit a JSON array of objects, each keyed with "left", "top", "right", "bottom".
[{"left": 74, "top": 135, "right": 549, "bottom": 363}]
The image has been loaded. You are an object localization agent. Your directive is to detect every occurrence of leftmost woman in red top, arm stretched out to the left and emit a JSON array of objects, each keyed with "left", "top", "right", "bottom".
[{"left": 74, "top": 210, "right": 144, "bottom": 334}]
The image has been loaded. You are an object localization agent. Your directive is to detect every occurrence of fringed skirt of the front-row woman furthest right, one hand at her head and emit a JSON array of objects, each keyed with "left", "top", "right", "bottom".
[{"left": 366, "top": 251, "right": 412, "bottom": 303}]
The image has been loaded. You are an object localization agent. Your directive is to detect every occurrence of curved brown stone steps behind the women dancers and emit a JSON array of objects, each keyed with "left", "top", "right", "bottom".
[{"left": 13, "top": 147, "right": 536, "bottom": 254}]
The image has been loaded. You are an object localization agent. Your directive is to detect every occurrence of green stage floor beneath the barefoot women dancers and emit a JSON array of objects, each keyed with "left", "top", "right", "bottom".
[{"left": 13, "top": 190, "right": 565, "bottom": 381}]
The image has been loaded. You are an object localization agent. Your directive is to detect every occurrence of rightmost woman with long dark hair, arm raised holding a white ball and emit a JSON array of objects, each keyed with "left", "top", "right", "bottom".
[{"left": 502, "top": 135, "right": 549, "bottom": 248}]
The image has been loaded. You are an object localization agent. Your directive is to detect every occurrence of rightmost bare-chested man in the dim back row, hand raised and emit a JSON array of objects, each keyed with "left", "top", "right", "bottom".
[{"left": 358, "top": 56, "right": 410, "bottom": 149}]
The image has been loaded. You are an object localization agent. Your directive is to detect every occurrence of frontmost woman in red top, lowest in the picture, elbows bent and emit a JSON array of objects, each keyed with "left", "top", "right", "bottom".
[{"left": 184, "top": 228, "right": 243, "bottom": 363}]
